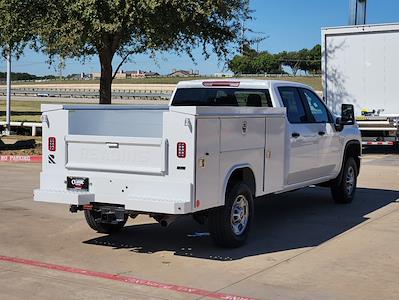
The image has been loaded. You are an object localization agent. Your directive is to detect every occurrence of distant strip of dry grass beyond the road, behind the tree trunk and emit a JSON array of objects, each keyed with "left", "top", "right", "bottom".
[{"left": 4, "top": 76, "right": 322, "bottom": 91}]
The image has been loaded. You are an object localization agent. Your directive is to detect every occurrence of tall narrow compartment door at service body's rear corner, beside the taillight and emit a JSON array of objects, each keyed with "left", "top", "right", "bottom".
[{"left": 194, "top": 118, "right": 220, "bottom": 211}]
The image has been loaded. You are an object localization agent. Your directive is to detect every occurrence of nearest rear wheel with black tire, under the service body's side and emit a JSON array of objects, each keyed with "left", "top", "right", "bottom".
[{"left": 208, "top": 182, "right": 253, "bottom": 248}]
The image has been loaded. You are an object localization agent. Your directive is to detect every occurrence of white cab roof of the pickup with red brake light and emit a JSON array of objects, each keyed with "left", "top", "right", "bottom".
[{"left": 177, "top": 78, "right": 312, "bottom": 89}]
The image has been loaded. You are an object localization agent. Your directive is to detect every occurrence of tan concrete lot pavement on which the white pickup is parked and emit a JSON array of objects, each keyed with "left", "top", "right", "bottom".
[{"left": 0, "top": 153, "right": 399, "bottom": 299}]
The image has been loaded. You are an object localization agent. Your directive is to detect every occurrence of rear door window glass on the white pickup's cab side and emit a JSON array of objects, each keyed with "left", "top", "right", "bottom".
[{"left": 278, "top": 87, "right": 307, "bottom": 123}]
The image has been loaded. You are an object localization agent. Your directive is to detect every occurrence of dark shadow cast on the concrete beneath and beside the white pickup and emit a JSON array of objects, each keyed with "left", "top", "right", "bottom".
[{"left": 84, "top": 188, "right": 399, "bottom": 261}]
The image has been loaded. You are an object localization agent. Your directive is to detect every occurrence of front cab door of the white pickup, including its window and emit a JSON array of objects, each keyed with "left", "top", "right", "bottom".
[{"left": 299, "top": 88, "right": 342, "bottom": 177}]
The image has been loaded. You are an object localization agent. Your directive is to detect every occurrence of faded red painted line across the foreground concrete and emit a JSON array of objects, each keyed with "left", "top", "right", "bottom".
[{"left": 0, "top": 255, "right": 255, "bottom": 300}]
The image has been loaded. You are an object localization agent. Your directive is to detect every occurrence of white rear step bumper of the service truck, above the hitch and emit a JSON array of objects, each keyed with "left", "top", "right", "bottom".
[{"left": 34, "top": 189, "right": 192, "bottom": 215}]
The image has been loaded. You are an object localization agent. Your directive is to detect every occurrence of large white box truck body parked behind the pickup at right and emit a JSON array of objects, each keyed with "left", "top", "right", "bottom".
[{"left": 322, "top": 24, "right": 399, "bottom": 146}]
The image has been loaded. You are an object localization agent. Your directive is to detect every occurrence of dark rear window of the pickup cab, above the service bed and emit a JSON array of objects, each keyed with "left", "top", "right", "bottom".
[{"left": 172, "top": 88, "right": 272, "bottom": 107}]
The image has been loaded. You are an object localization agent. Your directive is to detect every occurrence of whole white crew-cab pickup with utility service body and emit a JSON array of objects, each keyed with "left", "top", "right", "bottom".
[{"left": 34, "top": 80, "right": 361, "bottom": 247}]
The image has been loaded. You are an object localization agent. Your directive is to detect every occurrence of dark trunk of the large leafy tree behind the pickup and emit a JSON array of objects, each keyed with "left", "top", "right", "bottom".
[{"left": 100, "top": 51, "right": 114, "bottom": 104}]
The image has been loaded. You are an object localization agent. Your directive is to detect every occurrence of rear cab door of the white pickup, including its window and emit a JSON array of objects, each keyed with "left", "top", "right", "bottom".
[{"left": 278, "top": 87, "right": 320, "bottom": 185}]
